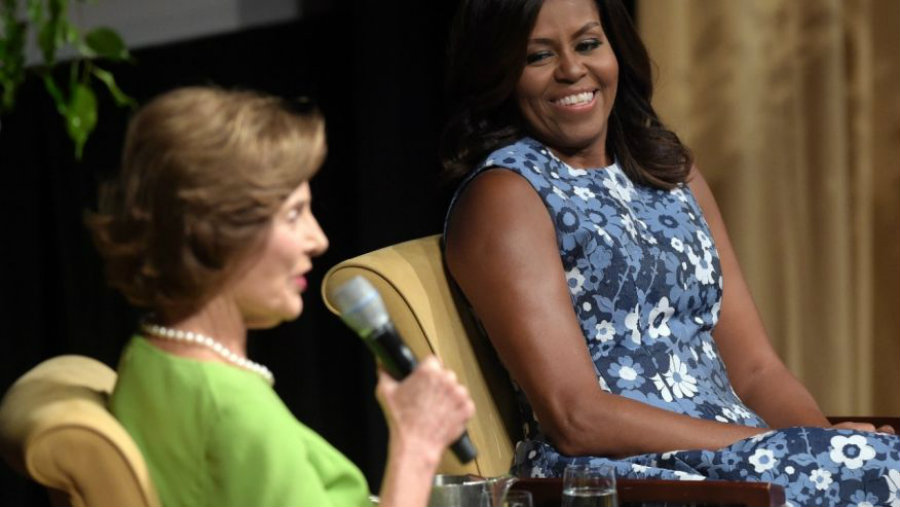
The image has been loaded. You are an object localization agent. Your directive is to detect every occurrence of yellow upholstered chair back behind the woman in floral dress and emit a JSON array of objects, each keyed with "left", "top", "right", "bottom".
[{"left": 322, "top": 235, "right": 521, "bottom": 477}]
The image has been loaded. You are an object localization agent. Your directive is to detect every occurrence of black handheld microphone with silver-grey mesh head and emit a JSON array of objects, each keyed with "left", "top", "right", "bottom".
[{"left": 332, "top": 276, "right": 478, "bottom": 463}]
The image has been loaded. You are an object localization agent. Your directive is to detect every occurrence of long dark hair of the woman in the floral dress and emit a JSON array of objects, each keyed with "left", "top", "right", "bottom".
[{"left": 441, "top": 0, "right": 693, "bottom": 189}]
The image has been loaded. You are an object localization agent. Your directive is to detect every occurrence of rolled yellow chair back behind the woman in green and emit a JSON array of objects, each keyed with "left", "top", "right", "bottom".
[{"left": 0, "top": 355, "right": 160, "bottom": 507}]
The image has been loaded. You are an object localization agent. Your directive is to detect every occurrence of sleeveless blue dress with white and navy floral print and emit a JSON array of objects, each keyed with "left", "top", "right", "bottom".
[{"left": 451, "top": 138, "right": 900, "bottom": 507}]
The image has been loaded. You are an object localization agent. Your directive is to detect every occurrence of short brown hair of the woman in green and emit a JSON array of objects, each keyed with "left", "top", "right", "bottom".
[{"left": 86, "top": 87, "right": 325, "bottom": 319}]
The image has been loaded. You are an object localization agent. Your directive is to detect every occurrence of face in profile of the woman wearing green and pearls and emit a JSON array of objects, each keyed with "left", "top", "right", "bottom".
[{"left": 228, "top": 182, "right": 328, "bottom": 328}]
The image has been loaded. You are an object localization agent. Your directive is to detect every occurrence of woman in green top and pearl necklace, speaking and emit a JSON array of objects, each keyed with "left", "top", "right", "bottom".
[{"left": 88, "top": 87, "right": 474, "bottom": 506}]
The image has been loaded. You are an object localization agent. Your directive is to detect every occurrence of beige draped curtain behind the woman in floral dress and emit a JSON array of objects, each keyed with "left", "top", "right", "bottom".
[{"left": 637, "top": 0, "right": 900, "bottom": 416}]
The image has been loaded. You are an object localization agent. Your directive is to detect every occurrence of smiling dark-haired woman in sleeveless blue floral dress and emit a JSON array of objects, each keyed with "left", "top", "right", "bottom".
[{"left": 443, "top": 0, "right": 900, "bottom": 506}]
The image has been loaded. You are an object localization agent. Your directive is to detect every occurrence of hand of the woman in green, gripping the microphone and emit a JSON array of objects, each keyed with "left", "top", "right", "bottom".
[{"left": 375, "top": 356, "right": 475, "bottom": 466}]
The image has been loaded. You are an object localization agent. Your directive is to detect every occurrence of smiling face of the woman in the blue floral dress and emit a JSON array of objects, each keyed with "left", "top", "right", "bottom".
[{"left": 515, "top": 0, "right": 619, "bottom": 167}]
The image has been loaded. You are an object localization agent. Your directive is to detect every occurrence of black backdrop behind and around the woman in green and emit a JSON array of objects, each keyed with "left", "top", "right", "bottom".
[{"left": 0, "top": 0, "right": 633, "bottom": 505}]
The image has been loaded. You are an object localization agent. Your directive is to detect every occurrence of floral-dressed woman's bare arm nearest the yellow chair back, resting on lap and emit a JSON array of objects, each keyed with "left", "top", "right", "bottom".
[{"left": 446, "top": 170, "right": 762, "bottom": 455}]
